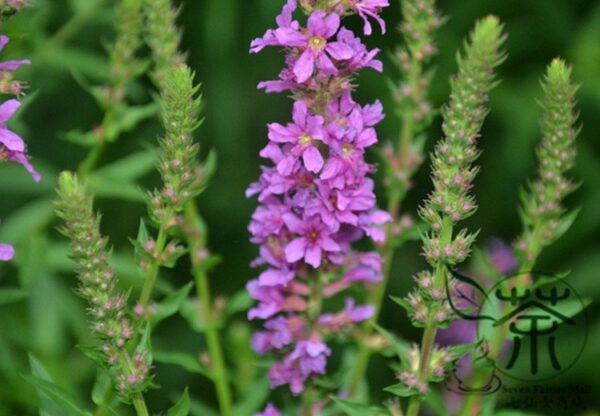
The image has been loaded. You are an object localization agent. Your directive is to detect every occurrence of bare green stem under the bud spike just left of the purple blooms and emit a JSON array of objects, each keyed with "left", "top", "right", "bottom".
[{"left": 184, "top": 201, "right": 233, "bottom": 416}]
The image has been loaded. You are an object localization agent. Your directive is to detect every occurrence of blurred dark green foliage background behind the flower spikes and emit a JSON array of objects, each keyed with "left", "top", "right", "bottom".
[{"left": 0, "top": 0, "right": 600, "bottom": 415}]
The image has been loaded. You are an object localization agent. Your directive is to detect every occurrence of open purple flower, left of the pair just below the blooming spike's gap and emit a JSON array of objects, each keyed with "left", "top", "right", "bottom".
[{"left": 269, "top": 101, "right": 325, "bottom": 176}]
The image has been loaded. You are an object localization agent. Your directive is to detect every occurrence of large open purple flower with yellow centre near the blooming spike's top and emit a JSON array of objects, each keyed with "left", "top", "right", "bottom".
[{"left": 275, "top": 10, "right": 353, "bottom": 83}]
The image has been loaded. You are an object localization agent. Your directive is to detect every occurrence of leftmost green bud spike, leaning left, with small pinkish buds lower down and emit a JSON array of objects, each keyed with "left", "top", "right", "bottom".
[{"left": 55, "top": 172, "right": 151, "bottom": 398}]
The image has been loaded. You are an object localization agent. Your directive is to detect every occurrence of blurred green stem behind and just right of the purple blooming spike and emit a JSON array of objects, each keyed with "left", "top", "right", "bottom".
[{"left": 349, "top": 61, "right": 422, "bottom": 397}]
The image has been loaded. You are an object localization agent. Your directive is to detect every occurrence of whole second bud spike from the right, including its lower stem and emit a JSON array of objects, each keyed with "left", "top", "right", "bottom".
[{"left": 401, "top": 16, "right": 504, "bottom": 416}]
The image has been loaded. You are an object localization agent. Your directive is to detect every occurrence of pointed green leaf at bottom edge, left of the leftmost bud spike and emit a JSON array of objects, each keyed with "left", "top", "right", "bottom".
[{"left": 23, "top": 354, "right": 91, "bottom": 416}]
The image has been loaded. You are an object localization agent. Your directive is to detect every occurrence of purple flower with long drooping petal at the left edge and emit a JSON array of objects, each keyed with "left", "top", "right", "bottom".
[{"left": 0, "top": 99, "right": 41, "bottom": 182}]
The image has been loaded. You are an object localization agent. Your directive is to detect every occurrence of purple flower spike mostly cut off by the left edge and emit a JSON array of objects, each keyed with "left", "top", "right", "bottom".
[{"left": 0, "top": 7, "right": 41, "bottom": 261}]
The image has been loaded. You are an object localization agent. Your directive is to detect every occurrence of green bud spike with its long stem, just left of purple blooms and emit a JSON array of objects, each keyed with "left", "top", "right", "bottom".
[{"left": 144, "top": 0, "right": 233, "bottom": 416}]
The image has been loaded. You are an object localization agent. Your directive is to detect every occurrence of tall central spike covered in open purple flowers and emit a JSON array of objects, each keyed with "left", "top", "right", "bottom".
[{"left": 247, "top": 0, "right": 389, "bottom": 396}]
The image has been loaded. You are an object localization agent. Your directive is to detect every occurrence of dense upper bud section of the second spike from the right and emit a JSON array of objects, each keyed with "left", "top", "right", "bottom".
[{"left": 421, "top": 17, "right": 504, "bottom": 231}]
